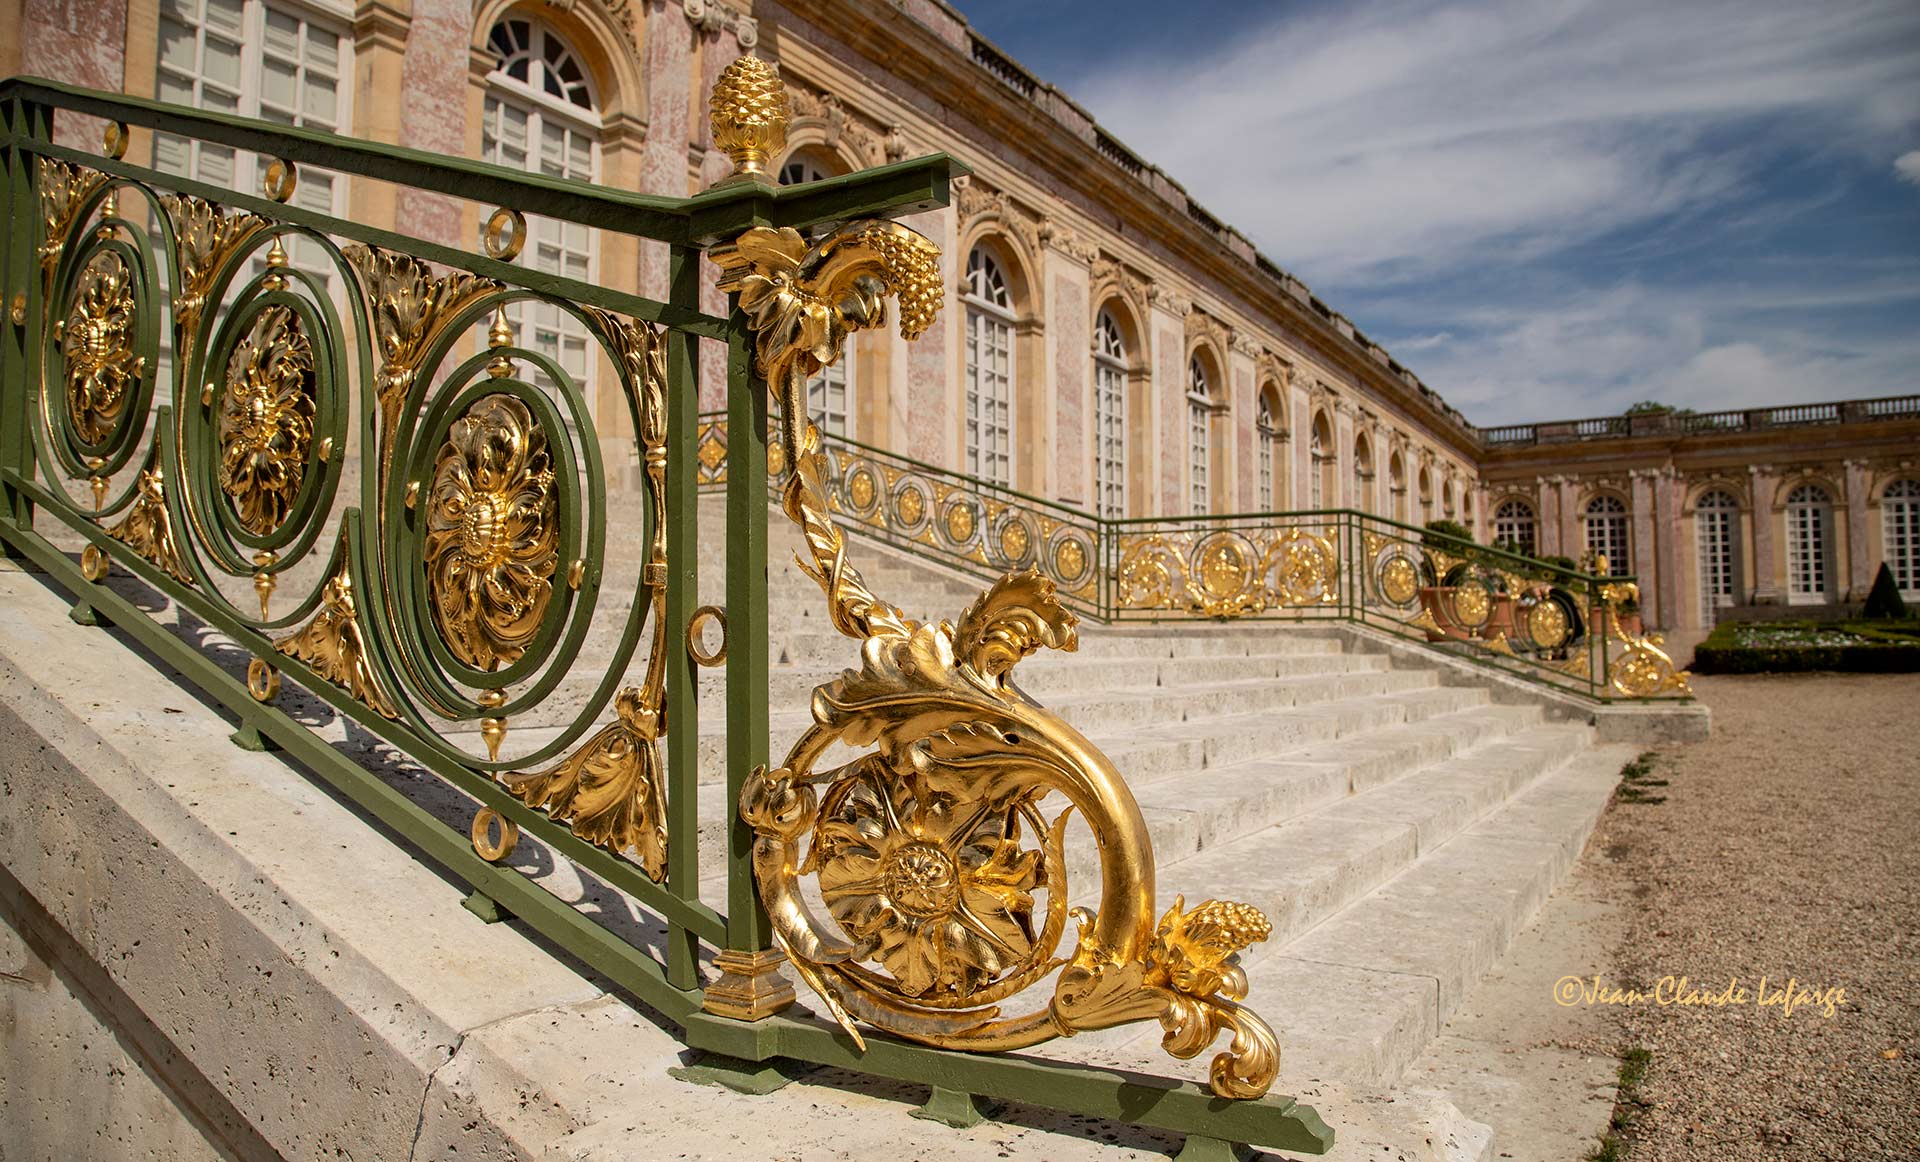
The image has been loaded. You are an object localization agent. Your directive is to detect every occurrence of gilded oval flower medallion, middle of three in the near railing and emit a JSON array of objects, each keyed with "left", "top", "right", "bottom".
[{"left": 215, "top": 305, "right": 315, "bottom": 536}]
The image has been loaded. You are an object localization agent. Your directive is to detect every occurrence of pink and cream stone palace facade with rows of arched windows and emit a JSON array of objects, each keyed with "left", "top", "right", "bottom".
[{"left": 0, "top": 0, "right": 1920, "bottom": 645}]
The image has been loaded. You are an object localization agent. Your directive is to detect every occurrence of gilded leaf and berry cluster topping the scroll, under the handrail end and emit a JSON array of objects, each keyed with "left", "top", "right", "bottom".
[{"left": 708, "top": 219, "right": 941, "bottom": 465}]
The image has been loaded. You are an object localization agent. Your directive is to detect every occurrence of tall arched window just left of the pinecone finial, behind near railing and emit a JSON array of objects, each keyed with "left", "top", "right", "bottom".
[{"left": 480, "top": 15, "right": 601, "bottom": 407}]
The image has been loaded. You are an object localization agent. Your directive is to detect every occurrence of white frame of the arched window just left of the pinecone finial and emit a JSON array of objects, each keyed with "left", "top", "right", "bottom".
[{"left": 480, "top": 12, "right": 605, "bottom": 419}]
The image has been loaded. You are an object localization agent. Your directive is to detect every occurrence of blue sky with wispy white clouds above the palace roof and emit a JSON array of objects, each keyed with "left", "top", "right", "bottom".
[{"left": 958, "top": 0, "right": 1920, "bottom": 424}]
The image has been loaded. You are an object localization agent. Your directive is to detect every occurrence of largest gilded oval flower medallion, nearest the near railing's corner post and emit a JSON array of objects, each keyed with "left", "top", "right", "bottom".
[{"left": 422, "top": 394, "right": 561, "bottom": 670}]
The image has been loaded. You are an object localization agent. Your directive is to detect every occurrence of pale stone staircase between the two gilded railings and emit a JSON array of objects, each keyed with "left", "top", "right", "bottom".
[{"left": 648, "top": 499, "right": 1636, "bottom": 1091}]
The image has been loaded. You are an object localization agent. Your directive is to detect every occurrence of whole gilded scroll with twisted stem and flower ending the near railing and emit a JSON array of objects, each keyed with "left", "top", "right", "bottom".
[{"left": 712, "top": 221, "right": 1279, "bottom": 1099}]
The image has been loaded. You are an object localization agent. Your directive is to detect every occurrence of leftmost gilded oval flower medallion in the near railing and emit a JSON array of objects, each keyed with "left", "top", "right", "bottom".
[{"left": 60, "top": 250, "right": 146, "bottom": 446}]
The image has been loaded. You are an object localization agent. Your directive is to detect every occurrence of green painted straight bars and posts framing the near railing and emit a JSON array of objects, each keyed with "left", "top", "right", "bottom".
[{"left": 0, "top": 79, "right": 1332, "bottom": 1152}]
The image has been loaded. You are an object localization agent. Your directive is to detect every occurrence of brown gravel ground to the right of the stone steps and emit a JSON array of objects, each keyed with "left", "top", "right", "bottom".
[{"left": 1597, "top": 674, "right": 1920, "bottom": 1162}]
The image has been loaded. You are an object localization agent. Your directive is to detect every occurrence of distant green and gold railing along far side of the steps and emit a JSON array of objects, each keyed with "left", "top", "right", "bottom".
[{"left": 701, "top": 413, "right": 1692, "bottom": 701}]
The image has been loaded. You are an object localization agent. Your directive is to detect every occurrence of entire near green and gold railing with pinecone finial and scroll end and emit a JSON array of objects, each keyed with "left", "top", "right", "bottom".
[{"left": 0, "top": 72, "right": 1332, "bottom": 1156}]
